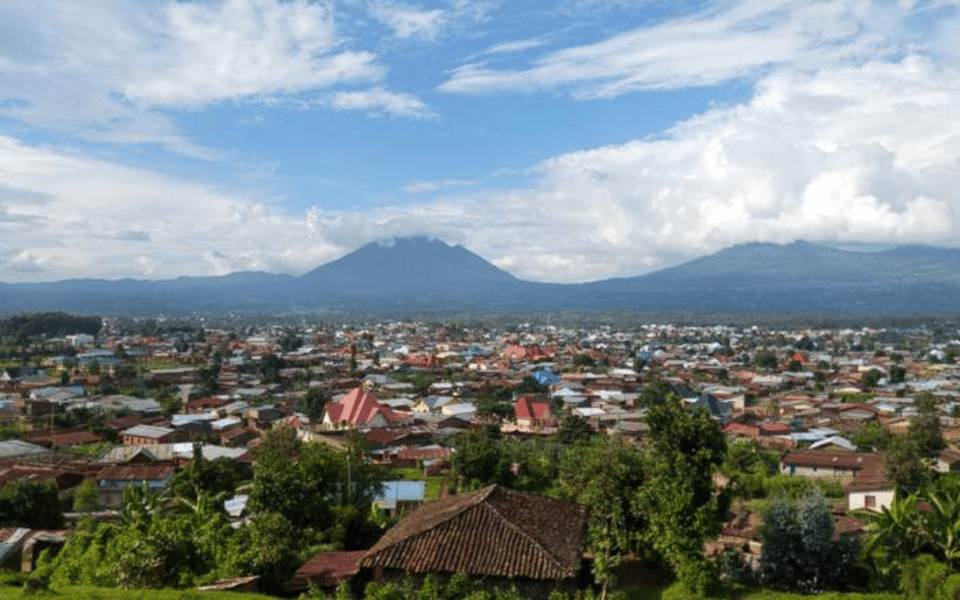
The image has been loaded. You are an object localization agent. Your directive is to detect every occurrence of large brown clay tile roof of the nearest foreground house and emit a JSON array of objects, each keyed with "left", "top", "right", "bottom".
[{"left": 360, "top": 485, "right": 587, "bottom": 580}]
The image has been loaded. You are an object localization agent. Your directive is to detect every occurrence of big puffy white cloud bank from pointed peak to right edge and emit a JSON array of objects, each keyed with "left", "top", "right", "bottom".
[{"left": 315, "top": 56, "right": 960, "bottom": 281}]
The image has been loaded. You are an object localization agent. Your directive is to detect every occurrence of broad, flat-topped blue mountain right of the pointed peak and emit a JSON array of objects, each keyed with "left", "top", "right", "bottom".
[{"left": 568, "top": 241, "right": 960, "bottom": 314}]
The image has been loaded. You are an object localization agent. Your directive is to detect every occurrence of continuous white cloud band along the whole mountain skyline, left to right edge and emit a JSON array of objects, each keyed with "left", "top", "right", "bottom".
[{"left": 7, "top": 55, "right": 960, "bottom": 281}]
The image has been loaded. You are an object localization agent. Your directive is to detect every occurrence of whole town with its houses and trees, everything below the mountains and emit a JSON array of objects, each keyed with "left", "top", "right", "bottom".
[{"left": 0, "top": 314, "right": 960, "bottom": 598}]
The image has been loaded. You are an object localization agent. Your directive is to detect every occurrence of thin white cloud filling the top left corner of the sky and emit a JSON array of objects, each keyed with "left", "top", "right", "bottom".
[{"left": 0, "top": 0, "right": 410, "bottom": 150}]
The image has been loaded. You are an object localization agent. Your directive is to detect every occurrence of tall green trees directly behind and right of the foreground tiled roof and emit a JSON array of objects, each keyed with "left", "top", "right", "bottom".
[{"left": 453, "top": 395, "right": 727, "bottom": 593}]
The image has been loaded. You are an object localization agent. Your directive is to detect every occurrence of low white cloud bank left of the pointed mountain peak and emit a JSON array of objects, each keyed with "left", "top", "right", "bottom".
[{"left": 0, "top": 136, "right": 340, "bottom": 281}]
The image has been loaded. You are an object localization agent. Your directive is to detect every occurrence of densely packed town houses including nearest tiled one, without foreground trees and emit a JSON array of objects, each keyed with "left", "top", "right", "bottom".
[{"left": 0, "top": 321, "right": 960, "bottom": 597}]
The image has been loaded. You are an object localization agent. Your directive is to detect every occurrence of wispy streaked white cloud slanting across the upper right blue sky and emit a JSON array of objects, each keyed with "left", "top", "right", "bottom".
[{"left": 439, "top": 0, "right": 902, "bottom": 98}]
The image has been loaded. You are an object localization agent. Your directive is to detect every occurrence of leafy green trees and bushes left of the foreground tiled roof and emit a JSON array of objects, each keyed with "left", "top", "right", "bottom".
[{"left": 37, "top": 427, "right": 382, "bottom": 592}]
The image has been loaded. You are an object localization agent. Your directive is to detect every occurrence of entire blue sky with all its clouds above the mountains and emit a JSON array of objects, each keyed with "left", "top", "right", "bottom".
[{"left": 0, "top": 0, "right": 960, "bottom": 282}]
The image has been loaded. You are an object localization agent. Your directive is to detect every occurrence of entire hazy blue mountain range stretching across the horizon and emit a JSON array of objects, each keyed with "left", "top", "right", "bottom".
[{"left": 0, "top": 238, "right": 960, "bottom": 315}]
